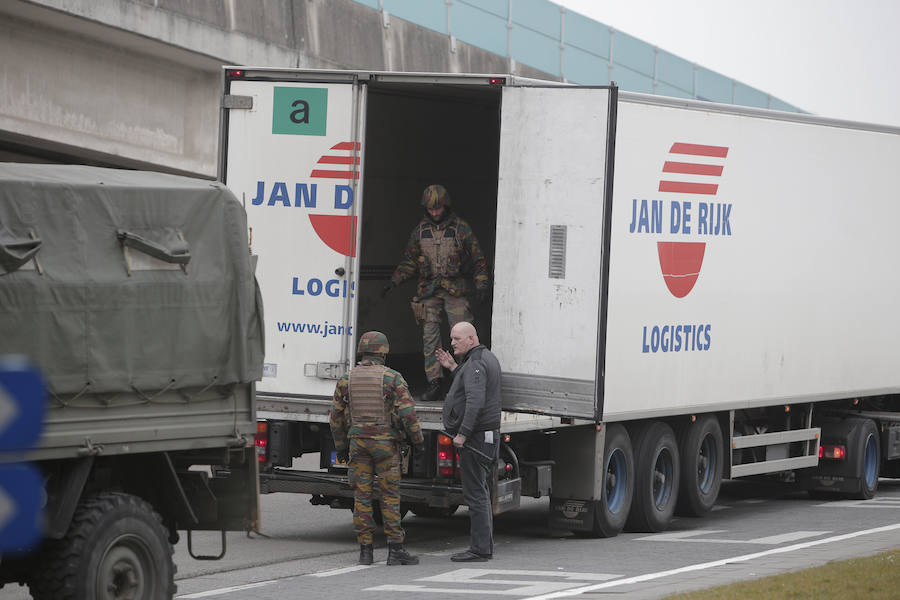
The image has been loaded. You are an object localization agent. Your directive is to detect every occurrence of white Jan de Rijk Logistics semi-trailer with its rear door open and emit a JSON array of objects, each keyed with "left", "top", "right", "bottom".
[{"left": 220, "top": 68, "right": 900, "bottom": 536}]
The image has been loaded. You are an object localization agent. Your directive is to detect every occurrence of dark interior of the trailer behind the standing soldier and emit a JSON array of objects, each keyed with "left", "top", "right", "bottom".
[{"left": 356, "top": 83, "right": 500, "bottom": 390}]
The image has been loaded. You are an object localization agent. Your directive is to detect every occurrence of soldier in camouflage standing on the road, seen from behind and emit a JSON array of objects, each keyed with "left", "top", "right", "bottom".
[{"left": 329, "top": 331, "right": 425, "bottom": 565}]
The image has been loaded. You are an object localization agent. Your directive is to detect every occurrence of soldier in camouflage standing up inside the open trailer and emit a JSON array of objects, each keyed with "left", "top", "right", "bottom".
[{"left": 381, "top": 185, "right": 488, "bottom": 401}]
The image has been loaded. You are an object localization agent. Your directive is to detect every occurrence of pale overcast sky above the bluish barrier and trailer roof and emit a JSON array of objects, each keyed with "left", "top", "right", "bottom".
[{"left": 553, "top": 0, "right": 900, "bottom": 127}]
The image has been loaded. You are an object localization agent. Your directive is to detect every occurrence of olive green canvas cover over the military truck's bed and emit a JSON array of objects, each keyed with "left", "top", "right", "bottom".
[{"left": 0, "top": 163, "right": 263, "bottom": 400}]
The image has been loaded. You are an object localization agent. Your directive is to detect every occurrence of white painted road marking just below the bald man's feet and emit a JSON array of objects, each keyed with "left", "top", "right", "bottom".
[{"left": 364, "top": 569, "right": 621, "bottom": 596}]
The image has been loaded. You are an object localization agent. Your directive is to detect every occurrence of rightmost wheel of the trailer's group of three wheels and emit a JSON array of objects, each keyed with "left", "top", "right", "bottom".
[{"left": 675, "top": 415, "right": 725, "bottom": 517}]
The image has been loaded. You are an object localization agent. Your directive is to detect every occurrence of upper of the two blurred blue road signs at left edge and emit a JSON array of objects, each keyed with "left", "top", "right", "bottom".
[{"left": 0, "top": 356, "right": 47, "bottom": 452}]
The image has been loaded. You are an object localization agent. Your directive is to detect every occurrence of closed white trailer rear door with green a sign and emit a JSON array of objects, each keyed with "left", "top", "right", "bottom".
[{"left": 220, "top": 72, "right": 365, "bottom": 397}]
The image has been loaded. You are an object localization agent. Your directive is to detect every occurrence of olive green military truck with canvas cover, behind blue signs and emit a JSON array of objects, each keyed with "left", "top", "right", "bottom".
[{"left": 0, "top": 163, "right": 263, "bottom": 600}]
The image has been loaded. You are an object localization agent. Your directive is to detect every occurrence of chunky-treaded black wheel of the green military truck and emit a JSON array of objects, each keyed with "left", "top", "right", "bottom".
[{"left": 28, "top": 493, "right": 176, "bottom": 600}]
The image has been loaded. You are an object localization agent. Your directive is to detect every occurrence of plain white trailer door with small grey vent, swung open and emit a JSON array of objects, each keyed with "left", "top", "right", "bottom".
[{"left": 492, "top": 86, "right": 616, "bottom": 419}]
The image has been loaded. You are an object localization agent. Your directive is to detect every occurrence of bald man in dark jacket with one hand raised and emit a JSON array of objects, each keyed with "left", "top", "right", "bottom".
[{"left": 435, "top": 321, "right": 500, "bottom": 562}]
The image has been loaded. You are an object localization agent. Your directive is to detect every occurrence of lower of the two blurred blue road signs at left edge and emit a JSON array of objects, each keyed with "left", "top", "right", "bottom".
[{"left": 0, "top": 463, "right": 44, "bottom": 554}]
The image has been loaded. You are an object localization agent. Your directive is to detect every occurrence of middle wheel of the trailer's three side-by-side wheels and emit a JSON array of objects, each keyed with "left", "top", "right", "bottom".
[{"left": 625, "top": 421, "right": 681, "bottom": 533}]
